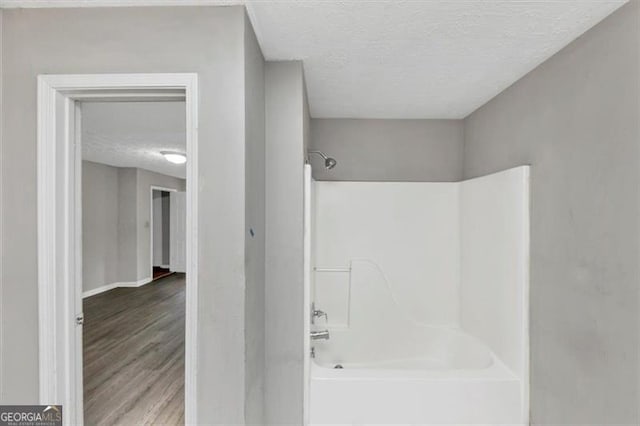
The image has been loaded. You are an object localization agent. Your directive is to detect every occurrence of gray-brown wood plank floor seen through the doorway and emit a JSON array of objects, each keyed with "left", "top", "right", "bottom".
[{"left": 83, "top": 274, "right": 185, "bottom": 426}]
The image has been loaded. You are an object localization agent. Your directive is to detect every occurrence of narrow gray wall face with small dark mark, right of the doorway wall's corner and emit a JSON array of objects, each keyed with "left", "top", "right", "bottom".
[{"left": 244, "top": 11, "right": 265, "bottom": 425}]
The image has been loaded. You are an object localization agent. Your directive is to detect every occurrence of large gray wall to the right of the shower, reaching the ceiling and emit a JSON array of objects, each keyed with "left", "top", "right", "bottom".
[{"left": 464, "top": 1, "right": 640, "bottom": 425}]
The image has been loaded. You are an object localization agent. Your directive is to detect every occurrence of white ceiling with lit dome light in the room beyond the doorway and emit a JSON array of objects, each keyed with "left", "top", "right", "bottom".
[{"left": 82, "top": 102, "right": 186, "bottom": 178}]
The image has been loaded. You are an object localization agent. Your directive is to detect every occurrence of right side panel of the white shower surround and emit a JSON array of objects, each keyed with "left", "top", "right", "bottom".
[{"left": 460, "top": 167, "right": 529, "bottom": 377}]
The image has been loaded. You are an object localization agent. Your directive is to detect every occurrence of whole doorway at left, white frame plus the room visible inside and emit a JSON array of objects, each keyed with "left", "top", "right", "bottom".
[{"left": 38, "top": 74, "right": 197, "bottom": 424}]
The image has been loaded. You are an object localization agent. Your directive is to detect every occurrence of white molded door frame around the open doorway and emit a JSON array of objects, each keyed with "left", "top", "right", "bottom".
[{"left": 37, "top": 73, "right": 198, "bottom": 424}]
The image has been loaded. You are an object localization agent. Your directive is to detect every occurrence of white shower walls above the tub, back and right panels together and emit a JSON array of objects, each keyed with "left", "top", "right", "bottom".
[{"left": 312, "top": 166, "right": 529, "bottom": 372}]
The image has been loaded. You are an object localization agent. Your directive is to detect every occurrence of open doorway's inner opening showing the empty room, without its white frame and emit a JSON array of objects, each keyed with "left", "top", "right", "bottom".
[{"left": 76, "top": 100, "right": 187, "bottom": 424}]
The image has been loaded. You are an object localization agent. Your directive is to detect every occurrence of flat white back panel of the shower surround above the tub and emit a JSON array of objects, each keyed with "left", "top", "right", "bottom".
[{"left": 314, "top": 182, "right": 460, "bottom": 326}]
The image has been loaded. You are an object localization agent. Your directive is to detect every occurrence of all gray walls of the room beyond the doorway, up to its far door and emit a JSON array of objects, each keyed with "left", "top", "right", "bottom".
[{"left": 82, "top": 161, "right": 185, "bottom": 291}]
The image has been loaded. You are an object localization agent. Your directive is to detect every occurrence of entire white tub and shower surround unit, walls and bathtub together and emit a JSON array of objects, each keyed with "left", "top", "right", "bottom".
[{"left": 306, "top": 166, "right": 529, "bottom": 425}]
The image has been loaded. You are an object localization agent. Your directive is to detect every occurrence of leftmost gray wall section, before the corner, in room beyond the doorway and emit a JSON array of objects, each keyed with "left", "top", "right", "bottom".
[{"left": 82, "top": 161, "right": 119, "bottom": 291}]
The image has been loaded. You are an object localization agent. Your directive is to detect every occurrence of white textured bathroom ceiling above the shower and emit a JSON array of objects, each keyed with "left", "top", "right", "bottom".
[{"left": 247, "top": 0, "right": 625, "bottom": 118}]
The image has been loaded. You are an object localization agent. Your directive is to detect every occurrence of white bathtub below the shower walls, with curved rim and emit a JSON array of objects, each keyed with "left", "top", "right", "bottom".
[{"left": 309, "top": 326, "right": 527, "bottom": 425}]
